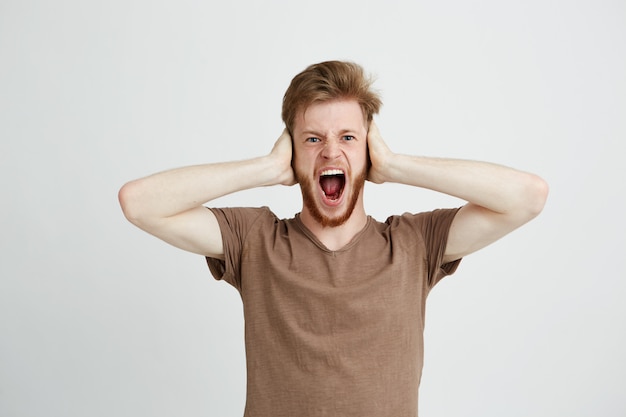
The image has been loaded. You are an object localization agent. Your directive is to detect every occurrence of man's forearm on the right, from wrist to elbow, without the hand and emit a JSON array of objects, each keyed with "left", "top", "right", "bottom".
[{"left": 384, "top": 154, "right": 547, "bottom": 216}]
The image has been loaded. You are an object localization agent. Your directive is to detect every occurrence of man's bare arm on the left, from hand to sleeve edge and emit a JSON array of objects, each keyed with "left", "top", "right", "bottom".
[{"left": 118, "top": 130, "right": 295, "bottom": 258}]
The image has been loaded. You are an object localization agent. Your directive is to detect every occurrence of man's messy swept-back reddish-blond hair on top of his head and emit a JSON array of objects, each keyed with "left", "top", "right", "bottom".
[{"left": 282, "top": 61, "right": 382, "bottom": 134}]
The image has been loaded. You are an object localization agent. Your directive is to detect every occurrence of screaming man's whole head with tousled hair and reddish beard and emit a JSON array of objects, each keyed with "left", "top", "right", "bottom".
[{"left": 283, "top": 61, "right": 381, "bottom": 227}]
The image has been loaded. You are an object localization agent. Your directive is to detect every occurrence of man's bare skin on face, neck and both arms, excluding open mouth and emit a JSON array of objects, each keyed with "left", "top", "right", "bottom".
[{"left": 119, "top": 96, "right": 548, "bottom": 262}]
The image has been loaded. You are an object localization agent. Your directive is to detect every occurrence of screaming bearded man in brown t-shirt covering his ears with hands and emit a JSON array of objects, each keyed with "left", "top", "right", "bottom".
[{"left": 119, "top": 61, "right": 547, "bottom": 417}]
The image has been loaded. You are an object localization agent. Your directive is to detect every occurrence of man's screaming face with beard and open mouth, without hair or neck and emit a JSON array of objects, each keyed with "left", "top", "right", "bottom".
[{"left": 293, "top": 100, "right": 368, "bottom": 227}]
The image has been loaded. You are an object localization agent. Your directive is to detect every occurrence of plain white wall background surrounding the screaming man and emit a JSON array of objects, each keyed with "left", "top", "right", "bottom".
[{"left": 0, "top": 0, "right": 626, "bottom": 417}]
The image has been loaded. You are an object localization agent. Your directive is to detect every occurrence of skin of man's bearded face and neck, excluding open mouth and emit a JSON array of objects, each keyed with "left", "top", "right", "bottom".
[{"left": 293, "top": 100, "right": 368, "bottom": 248}]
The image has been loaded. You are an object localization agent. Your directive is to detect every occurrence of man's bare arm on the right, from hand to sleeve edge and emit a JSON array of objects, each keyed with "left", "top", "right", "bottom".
[{"left": 368, "top": 123, "right": 548, "bottom": 262}]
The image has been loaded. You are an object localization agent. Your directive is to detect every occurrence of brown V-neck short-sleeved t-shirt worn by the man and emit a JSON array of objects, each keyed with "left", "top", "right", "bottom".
[{"left": 207, "top": 208, "right": 460, "bottom": 417}]
